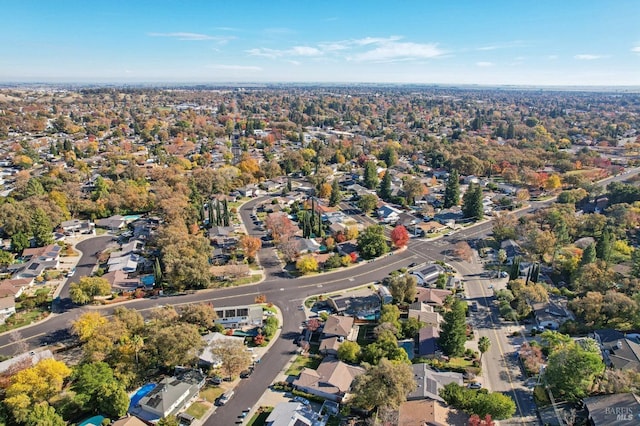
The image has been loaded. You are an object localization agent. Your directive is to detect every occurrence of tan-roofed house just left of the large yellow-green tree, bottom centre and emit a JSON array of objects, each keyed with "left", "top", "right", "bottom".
[{"left": 293, "top": 358, "right": 365, "bottom": 403}]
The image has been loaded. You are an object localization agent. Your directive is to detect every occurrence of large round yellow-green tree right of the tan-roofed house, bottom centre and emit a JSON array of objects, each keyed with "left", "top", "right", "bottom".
[{"left": 352, "top": 359, "right": 417, "bottom": 410}]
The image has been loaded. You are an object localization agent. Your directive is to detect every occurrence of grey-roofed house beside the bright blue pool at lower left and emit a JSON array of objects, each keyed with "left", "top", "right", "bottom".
[{"left": 139, "top": 370, "right": 206, "bottom": 418}]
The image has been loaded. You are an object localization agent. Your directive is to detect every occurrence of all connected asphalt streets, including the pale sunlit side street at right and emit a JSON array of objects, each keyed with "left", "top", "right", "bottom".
[{"left": 0, "top": 168, "right": 640, "bottom": 425}]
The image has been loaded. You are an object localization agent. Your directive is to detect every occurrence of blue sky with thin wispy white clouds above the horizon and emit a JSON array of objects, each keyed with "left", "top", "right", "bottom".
[{"left": 0, "top": 0, "right": 640, "bottom": 86}]
